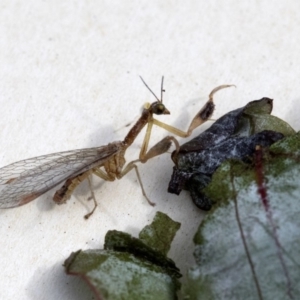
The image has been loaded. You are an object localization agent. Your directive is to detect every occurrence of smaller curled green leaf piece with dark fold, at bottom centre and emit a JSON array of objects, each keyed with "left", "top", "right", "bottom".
[{"left": 64, "top": 213, "right": 181, "bottom": 300}]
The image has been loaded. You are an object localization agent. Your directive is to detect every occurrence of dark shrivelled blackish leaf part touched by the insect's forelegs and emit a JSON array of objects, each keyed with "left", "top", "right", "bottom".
[{"left": 168, "top": 98, "right": 284, "bottom": 210}]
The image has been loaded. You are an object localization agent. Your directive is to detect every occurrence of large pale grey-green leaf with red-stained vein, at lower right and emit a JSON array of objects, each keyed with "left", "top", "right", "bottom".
[{"left": 186, "top": 133, "right": 300, "bottom": 300}]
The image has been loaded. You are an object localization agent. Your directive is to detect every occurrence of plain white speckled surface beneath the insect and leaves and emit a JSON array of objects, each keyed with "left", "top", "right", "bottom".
[{"left": 0, "top": 0, "right": 300, "bottom": 300}]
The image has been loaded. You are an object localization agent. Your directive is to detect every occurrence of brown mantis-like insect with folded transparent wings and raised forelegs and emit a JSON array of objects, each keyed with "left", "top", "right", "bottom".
[{"left": 0, "top": 77, "right": 232, "bottom": 219}]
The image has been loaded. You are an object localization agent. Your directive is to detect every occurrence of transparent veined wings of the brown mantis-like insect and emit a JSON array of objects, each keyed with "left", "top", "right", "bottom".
[{"left": 0, "top": 142, "right": 121, "bottom": 208}]
